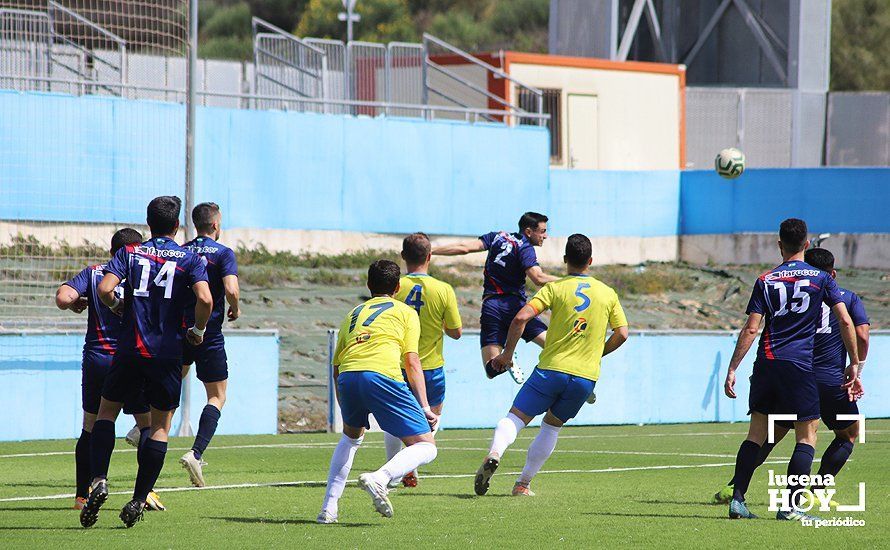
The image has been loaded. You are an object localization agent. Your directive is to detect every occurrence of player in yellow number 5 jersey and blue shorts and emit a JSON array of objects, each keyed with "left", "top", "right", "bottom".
[{"left": 474, "top": 233, "right": 627, "bottom": 496}]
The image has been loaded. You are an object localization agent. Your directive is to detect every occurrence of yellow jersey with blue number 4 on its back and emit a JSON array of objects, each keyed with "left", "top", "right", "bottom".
[{"left": 395, "top": 273, "right": 461, "bottom": 370}]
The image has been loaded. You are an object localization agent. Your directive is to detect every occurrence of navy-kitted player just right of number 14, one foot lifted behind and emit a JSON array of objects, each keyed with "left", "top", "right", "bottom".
[{"left": 179, "top": 202, "right": 241, "bottom": 487}]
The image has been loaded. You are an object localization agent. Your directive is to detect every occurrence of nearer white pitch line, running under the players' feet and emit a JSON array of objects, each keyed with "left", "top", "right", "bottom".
[{"left": 0, "top": 459, "right": 792, "bottom": 504}]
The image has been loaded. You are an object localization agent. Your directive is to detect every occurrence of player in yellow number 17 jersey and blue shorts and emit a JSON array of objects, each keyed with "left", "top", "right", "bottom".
[{"left": 316, "top": 260, "right": 439, "bottom": 523}]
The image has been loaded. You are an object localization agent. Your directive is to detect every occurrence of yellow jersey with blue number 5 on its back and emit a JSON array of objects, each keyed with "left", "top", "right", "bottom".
[{"left": 528, "top": 275, "right": 627, "bottom": 380}]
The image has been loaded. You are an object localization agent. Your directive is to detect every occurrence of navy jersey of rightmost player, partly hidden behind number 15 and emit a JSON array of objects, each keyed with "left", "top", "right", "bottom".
[{"left": 813, "top": 288, "right": 869, "bottom": 386}]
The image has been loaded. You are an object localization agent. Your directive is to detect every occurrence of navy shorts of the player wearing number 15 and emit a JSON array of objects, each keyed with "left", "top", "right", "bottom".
[{"left": 748, "top": 359, "right": 819, "bottom": 421}]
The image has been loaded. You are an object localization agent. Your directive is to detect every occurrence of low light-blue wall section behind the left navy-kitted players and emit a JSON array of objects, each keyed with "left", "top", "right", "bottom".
[{"left": 0, "top": 332, "right": 278, "bottom": 441}]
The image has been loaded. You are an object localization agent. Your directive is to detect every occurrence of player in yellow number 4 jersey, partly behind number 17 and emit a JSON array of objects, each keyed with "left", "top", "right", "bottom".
[{"left": 383, "top": 233, "right": 461, "bottom": 487}]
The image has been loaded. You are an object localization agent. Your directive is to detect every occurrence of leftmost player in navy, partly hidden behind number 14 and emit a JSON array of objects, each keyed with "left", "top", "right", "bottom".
[{"left": 56, "top": 227, "right": 164, "bottom": 510}]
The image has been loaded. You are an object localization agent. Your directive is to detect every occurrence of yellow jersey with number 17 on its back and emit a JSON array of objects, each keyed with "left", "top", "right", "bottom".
[{"left": 334, "top": 296, "right": 420, "bottom": 382}]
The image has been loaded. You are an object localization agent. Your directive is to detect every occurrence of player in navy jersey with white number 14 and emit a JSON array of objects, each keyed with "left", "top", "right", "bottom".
[{"left": 80, "top": 197, "right": 213, "bottom": 527}]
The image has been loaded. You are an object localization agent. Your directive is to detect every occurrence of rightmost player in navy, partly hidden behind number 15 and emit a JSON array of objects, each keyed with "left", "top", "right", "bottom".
[{"left": 714, "top": 248, "right": 869, "bottom": 503}]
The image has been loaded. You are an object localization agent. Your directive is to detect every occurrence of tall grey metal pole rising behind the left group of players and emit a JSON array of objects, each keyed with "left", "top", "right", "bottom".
[{"left": 176, "top": 0, "right": 198, "bottom": 437}]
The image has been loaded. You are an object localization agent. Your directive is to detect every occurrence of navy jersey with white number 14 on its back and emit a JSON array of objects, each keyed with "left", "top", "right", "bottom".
[{"left": 106, "top": 237, "right": 207, "bottom": 359}]
